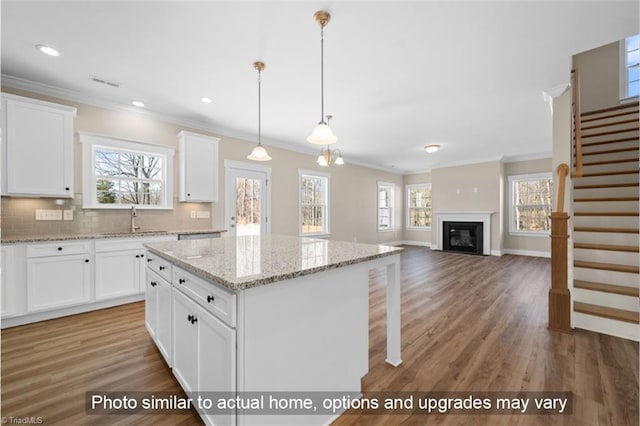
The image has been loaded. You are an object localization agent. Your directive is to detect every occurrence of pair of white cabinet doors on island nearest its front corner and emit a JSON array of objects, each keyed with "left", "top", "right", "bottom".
[{"left": 172, "top": 288, "right": 236, "bottom": 425}]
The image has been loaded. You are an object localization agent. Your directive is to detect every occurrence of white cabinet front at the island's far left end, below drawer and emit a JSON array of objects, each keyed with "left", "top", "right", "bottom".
[{"left": 145, "top": 271, "right": 173, "bottom": 367}]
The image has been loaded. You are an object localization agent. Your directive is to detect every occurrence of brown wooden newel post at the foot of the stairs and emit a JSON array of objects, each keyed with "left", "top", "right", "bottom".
[{"left": 549, "top": 164, "right": 571, "bottom": 332}]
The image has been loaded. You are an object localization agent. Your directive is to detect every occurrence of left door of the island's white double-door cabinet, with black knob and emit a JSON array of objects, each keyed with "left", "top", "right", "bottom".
[{"left": 172, "top": 289, "right": 198, "bottom": 392}]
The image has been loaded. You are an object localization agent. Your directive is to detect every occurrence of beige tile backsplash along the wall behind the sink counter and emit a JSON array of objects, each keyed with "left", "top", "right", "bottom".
[{"left": 1, "top": 194, "right": 212, "bottom": 237}]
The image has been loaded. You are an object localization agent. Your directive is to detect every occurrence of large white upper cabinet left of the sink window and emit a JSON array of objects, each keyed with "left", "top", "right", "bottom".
[{"left": 1, "top": 93, "right": 76, "bottom": 198}]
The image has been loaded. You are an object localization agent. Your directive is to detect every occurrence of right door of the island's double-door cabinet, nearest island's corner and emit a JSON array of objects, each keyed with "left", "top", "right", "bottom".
[{"left": 197, "top": 307, "right": 236, "bottom": 425}]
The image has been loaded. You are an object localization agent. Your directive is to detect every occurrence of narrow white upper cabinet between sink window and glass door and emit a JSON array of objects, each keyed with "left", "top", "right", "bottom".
[{"left": 178, "top": 131, "right": 220, "bottom": 203}]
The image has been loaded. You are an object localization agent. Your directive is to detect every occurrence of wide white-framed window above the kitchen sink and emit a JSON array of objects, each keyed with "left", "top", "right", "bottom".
[{"left": 80, "top": 134, "right": 173, "bottom": 209}]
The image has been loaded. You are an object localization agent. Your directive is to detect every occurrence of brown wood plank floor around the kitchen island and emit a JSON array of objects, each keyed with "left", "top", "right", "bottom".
[{"left": 1, "top": 247, "right": 639, "bottom": 426}]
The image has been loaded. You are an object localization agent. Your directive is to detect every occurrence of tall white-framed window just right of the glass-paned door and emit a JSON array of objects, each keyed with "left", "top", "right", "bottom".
[{"left": 300, "top": 171, "right": 329, "bottom": 236}]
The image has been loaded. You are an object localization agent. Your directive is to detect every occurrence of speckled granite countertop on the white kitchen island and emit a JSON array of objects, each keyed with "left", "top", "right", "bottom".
[{"left": 145, "top": 235, "right": 403, "bottom": 291}]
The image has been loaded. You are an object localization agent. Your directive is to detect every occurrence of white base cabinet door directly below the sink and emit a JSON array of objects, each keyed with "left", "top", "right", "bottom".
[{"left": 96, "top": 250, "right": 142, "bottom": 300}]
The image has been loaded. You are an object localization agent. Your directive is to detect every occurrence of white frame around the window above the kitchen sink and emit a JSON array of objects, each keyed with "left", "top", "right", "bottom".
[{"left": 80, "top": 133, "right": 175, "bottom": 210}]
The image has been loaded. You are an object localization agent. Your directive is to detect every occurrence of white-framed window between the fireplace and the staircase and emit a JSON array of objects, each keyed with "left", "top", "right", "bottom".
[{"left": 509, "top": 173, "right": 552, "bottom": 236}]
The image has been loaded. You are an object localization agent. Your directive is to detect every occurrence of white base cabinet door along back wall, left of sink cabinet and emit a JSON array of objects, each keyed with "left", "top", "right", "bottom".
[{"left": 27, "top": 255, "right": 92, "bottom": 312}]
